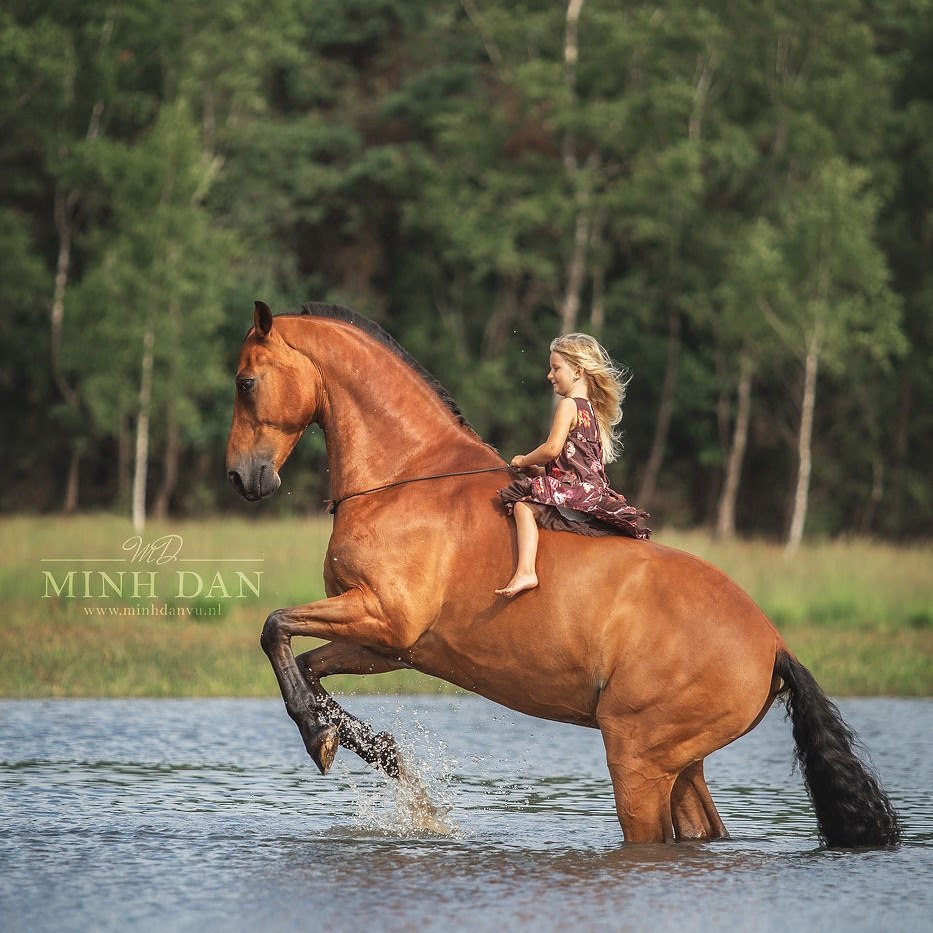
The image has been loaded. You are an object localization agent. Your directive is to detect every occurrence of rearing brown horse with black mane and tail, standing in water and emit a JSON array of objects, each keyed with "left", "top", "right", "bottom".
[{"left": 227, "top": 301, "right": 899, "bottom": 846}]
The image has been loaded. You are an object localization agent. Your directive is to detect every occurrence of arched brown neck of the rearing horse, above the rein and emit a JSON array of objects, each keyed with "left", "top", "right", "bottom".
[{"left": 290, "top": 318, "right": 501, "bottom": 497}]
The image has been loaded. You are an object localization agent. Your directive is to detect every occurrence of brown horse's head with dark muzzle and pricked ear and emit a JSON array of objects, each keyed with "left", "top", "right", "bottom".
[{"left": 227, "top": 301, "right": 321, "bottom": 501}]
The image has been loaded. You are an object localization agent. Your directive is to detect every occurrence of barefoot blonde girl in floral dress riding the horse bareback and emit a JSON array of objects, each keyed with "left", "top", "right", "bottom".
[{"left": 496, "top": 334, "right": 651, "bottom": 597}]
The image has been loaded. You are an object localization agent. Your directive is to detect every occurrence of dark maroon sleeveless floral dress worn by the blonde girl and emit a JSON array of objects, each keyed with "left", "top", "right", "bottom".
[{"left": 499, "top": 398, "right": 651, "bottom": 538}]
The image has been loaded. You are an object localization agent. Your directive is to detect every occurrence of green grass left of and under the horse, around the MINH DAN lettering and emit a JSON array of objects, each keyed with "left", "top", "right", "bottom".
[{"left": 0, "top": 516, "right": 454, "bottom": 697}]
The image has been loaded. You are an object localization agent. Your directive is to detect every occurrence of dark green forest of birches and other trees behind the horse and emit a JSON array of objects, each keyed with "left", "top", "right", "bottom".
[{"left": 0, "top": 0, "right": 933, "bottom": 546}]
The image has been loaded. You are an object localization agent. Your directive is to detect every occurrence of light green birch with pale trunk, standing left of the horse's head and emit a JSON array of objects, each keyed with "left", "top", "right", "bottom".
[{"left": 69, "top": 104, "right": 234, "bottom": 529}]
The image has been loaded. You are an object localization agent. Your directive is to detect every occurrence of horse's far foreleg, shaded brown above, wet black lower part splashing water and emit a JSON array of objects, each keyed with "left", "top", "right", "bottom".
[{"left": 295, "top": 642, "right": 408, "bottom": 778}]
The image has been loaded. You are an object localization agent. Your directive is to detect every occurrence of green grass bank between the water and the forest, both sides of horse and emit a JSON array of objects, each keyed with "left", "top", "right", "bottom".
[{"left": 0, "top": 516, "right": 933, "bottom": 697}]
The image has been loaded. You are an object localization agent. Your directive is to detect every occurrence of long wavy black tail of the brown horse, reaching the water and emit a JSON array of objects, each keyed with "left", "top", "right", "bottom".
[{"left": 774, "top": 651, "right": 901, "bottom": 847}]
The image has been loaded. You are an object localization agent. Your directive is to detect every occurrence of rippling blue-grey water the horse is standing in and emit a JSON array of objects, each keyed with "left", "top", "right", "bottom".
[{"left": 0, "top": 697, "right": 933, "bottom": 933}]
